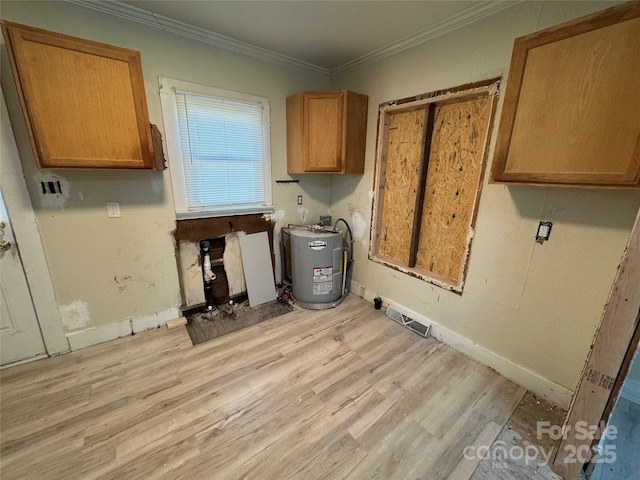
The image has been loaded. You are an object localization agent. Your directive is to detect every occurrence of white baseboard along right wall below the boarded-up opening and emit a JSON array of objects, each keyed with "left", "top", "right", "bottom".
[{"left": 350, "top": 281, "right": 573, "bottom": 410}]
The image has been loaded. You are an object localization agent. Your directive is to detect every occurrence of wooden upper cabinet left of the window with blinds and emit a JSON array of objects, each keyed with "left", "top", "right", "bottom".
[{"left": 2, "top": 22, "right": 163, "bottom": 170}]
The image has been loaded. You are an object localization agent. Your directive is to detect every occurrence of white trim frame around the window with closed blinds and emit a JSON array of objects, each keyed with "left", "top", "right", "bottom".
[{"left": 158, "top": 77, "right": 273, "bottom": 220}]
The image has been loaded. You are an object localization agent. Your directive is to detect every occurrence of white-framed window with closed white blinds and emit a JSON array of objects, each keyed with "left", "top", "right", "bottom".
[{"left": 160, "top": 78, "right": 271, "bottom": 218}]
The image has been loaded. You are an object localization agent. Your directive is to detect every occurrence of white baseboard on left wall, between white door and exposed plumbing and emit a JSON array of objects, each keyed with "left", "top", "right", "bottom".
[{"left": 67, "top": 307, "right": 182, "bottom": 352}]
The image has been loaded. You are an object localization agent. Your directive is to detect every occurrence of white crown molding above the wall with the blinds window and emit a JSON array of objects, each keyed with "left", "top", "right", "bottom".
[{"left": 66, "top": 0, "right": 331, "bottom": 77}]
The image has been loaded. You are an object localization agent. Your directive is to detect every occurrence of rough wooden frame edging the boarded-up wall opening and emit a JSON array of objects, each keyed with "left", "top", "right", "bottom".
[{"left": 369, "top": 78, "right": 501, "bottom": 293}]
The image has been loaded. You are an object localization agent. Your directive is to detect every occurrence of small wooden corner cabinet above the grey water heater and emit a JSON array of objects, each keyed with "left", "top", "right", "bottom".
[{"left": 287, "top": 90, "right": 368, "bottom": 173}]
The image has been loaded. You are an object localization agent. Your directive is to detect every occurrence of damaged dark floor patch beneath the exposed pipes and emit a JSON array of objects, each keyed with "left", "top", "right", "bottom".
[{"left": 185, "top": 300, "right": 294, "bottom": 345}]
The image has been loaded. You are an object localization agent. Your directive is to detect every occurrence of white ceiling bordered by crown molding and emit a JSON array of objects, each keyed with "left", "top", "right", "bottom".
[{"left": 71, "top": 0, "right": 515, "bottom": 74}]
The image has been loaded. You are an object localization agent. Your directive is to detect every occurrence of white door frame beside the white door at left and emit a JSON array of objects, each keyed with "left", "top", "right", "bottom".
[{"left": 0, "top": 88, "right": 70, "bottom": 355}]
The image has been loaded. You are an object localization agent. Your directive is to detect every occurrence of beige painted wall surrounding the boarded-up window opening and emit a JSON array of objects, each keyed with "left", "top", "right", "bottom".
[{"left": 331, "top": 2, "right": 640, "bottom": 390}]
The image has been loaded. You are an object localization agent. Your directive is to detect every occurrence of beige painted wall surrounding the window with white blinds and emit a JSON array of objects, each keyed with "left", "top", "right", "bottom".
[{"left": 1, "top": 0, "right": 329, "bottom": 332}]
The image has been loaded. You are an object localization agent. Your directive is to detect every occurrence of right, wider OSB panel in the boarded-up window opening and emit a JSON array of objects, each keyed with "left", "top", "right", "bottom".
[{"left": 416, "top": 97, "right": 491, "bottom": 283}]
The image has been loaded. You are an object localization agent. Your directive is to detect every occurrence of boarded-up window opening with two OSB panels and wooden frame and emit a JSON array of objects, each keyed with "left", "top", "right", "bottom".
[{"left": 370, "top": 79, "right": 499, "bottom": 292}]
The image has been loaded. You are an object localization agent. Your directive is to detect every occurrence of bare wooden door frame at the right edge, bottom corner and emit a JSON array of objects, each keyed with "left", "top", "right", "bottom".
[{"left": 553, "top": 205, "right": 640, "bottom": 480}]
